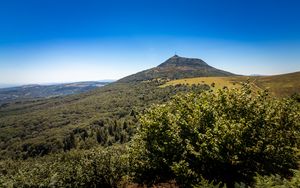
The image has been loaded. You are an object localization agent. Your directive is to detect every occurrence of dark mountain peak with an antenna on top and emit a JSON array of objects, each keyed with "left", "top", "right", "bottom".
[{"left": 119, "top": 55, "right": 234, "bottom": 82}]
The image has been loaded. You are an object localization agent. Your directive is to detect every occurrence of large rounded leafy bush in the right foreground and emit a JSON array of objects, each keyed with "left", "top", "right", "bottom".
[{"left": 131, "top": 85, "right": 300, "bottom": 187}]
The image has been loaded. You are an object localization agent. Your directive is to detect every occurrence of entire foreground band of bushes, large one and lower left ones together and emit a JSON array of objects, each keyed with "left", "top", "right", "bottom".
[{"left": 0, "top": 86, "right": 300, "bottom": 187}]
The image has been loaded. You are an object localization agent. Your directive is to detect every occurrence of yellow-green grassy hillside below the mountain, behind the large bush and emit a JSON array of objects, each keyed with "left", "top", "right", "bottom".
[{"left": 161, "top": 72, "right": 300, "bottom": 97}]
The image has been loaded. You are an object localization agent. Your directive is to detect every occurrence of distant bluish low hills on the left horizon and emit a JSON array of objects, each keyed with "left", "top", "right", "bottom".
[{"left": 0, "top": 82, "right": 108, "bottom": 104}]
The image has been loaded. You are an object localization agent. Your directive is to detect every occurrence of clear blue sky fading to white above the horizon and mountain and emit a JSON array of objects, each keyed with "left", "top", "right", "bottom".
[{"left": 0, "top": 0, "right": 300, "bottom": 84}]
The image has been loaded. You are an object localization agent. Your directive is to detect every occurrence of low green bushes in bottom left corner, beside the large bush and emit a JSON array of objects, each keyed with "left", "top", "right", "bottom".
[{"left": 0, "top": 146, "right": 128, "bottom": 187}]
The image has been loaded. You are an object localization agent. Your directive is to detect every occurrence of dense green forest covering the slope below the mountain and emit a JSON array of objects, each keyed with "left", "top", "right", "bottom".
[{"left": 0, "top": 80, "right": 209, "bottom": 159}]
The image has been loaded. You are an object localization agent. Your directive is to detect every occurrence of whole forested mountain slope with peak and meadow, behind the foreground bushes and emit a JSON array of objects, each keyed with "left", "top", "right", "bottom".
[{"left": 0, "top": 56, "right": 299, "bottom": 159}]
